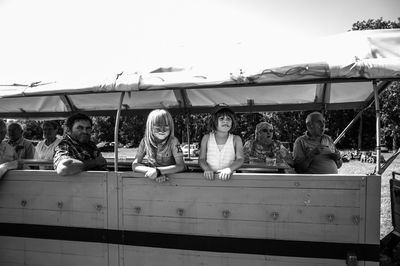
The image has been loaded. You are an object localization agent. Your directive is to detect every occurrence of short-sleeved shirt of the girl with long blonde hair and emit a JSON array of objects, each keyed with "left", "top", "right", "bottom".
[{"left": 137, "top": 137, "right": 183, "bottom": 167}]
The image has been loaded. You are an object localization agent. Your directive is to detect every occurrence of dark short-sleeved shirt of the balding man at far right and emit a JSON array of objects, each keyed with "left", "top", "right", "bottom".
[{"left": 293, "top": 133, "right": 338, "bottom": 174}]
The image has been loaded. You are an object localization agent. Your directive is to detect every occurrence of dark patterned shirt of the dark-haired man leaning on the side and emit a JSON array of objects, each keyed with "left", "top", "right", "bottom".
[{"left": 53, "top": 134, "right": 107, "bottom": 171}]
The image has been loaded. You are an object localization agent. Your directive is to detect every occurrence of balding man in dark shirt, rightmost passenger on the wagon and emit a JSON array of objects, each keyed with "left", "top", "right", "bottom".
[{"left": 293, "top": 112, "right": 342, "bottom": 174}]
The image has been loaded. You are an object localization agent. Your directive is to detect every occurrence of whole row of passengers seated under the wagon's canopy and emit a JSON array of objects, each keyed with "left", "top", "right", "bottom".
[{"left": 0, "top": 107, "right": 342, "bottom": 182}]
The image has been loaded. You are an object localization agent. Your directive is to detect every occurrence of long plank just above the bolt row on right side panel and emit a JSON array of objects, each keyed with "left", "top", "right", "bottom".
[{"left": 122, "top": 184, "right": 360, "bottom": 207}]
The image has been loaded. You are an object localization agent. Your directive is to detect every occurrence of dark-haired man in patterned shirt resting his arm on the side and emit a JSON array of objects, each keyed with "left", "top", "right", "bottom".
[{"left": 53, "top": 113, "right": 107, "bottom": 175}]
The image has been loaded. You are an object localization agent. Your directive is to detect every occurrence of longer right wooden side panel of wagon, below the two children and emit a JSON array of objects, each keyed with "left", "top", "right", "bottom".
[{"left": 122, "top": 173, "right": 364, "bottom": 243}]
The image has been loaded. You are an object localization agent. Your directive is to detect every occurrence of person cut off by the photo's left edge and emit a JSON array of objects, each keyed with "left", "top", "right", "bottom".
[{"left": 0, "top": 119, "right": 18, "bottom": 178}]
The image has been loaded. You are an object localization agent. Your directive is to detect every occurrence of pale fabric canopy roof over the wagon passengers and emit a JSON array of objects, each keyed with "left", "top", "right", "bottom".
[{"left": 0, "top": 30, "right": 400, "bottom": 118}]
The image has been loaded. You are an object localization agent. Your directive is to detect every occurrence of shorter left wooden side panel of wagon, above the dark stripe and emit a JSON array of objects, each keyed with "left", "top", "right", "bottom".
[{"left": 0, "top": 170, "right": 108, "bottom": 228}]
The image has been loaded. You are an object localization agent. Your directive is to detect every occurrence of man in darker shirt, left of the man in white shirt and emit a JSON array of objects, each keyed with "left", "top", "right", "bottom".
[{"left": 8, "top": 123, "right": 35, "bottom": 160}]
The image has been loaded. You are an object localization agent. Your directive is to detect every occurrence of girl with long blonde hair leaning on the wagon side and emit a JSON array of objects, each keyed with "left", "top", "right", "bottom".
[{"left": 132, "top": 109, "right": 185, "bottom": 182}]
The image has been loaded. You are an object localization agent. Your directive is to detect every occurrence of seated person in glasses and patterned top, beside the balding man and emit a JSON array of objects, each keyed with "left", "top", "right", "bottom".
[{"left": 243, "top": 122, "right": 293, "bottom": 166}]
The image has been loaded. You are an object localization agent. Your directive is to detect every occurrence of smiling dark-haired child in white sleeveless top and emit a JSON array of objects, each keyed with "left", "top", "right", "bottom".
[{"left": 199, "top": 107, "right": 243, "bottom": 180}]
